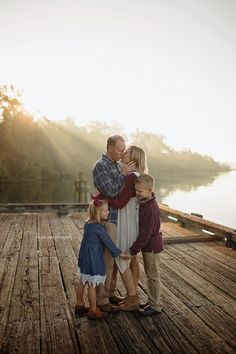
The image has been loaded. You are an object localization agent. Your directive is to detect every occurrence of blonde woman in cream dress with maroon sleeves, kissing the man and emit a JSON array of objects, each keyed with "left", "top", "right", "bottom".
[{"left": 108, "top": 145, "right": 147, "bottom": 311}]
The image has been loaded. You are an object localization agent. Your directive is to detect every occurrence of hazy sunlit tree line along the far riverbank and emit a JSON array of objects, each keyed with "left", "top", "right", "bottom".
[{"left": 0, "top": 86, "right": 229, "bottom": 182}]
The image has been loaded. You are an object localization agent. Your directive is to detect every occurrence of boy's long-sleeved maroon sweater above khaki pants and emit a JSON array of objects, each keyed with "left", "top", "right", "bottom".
[{"left": 130, "top": 194, "right": 164, "bottom": 256}]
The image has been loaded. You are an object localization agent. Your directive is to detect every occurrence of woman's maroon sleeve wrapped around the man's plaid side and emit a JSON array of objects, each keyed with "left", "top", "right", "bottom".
[{"left": 107, "top": 173, "right": 137, "bottom": 209}]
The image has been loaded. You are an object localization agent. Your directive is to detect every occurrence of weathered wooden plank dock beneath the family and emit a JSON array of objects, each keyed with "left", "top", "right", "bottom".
[{"left": 0, "top": 206, "right": 236, "bottom": 354}]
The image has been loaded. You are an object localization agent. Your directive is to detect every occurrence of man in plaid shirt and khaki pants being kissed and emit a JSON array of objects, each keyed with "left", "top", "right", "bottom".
[{"left": 93, "top": 135, "right": 135, "bottom": 312}]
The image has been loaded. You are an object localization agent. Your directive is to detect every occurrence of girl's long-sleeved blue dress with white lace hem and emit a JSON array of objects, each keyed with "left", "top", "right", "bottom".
[{"left": 78, "top": 223, "right": 121, "bottom": 287}]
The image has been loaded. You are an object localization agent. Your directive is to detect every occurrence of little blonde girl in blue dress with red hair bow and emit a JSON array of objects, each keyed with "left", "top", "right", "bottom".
[{"left": 75, "top": 198, "right": 127, "bottom": 319}]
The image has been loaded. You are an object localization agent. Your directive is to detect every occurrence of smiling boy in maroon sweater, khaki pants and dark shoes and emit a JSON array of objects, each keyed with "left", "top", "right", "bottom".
[{"left": 130, "top": 173, "right": 164, "bottom": 316}]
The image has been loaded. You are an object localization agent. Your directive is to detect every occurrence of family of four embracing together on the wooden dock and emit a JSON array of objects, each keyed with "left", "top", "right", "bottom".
[{"left": 75, "top": 135, "right": 163, "bottom": 319}]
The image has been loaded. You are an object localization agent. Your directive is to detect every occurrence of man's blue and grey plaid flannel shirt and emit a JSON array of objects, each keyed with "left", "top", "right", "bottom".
[{"left": 92, "top": 154, "right": 126, "bottom": 224}]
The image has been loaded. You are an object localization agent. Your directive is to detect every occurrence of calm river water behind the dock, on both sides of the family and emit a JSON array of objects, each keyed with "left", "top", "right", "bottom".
[{"left": 0, "top": 171, "right": 236, "bottom": 229}]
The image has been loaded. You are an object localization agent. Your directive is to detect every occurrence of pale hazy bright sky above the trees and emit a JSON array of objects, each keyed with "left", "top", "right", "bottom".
[{"left": 0, "top": 0, "right": 236, "bottom": 167}]
